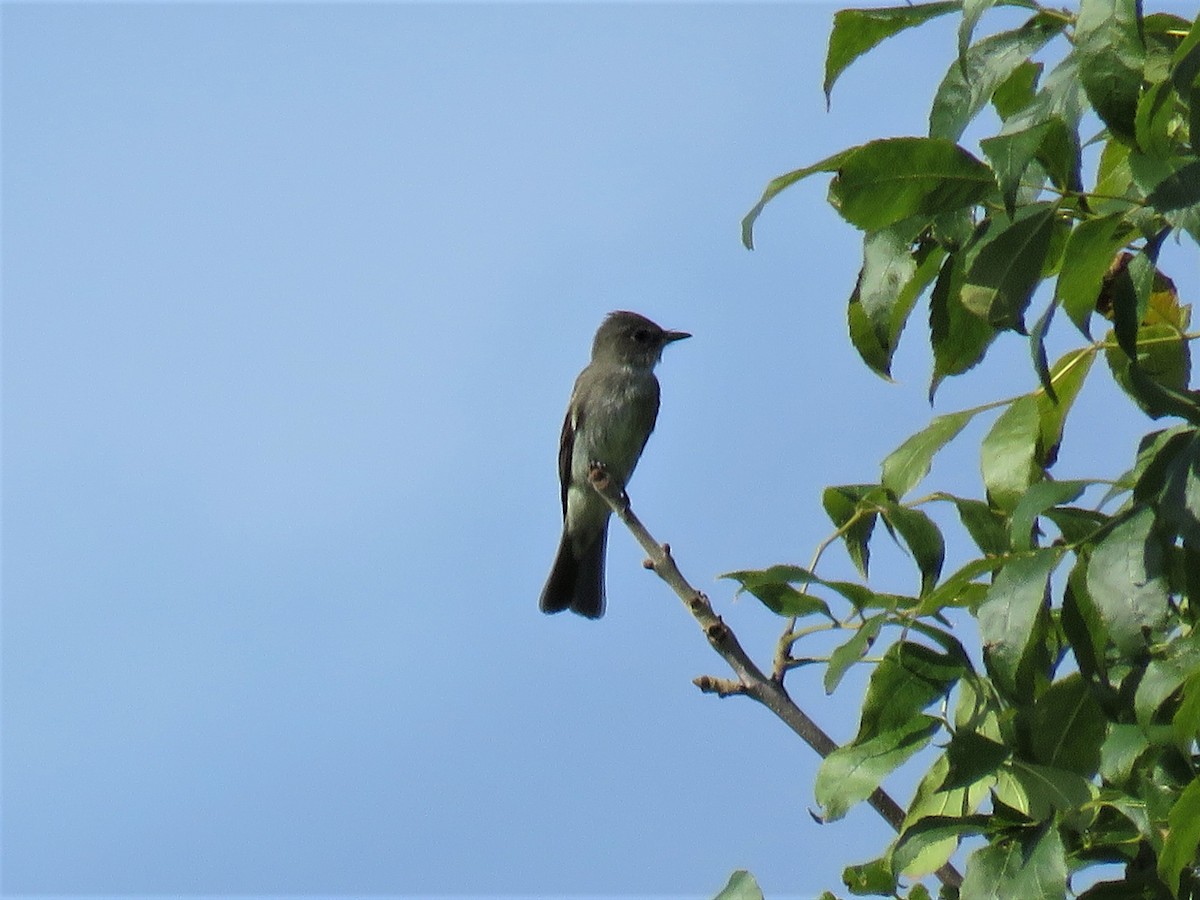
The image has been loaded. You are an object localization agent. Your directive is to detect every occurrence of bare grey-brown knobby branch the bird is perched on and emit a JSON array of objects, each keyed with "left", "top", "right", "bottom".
[{"left": 588, "top": 466, "right": 962, "bottom": 888}]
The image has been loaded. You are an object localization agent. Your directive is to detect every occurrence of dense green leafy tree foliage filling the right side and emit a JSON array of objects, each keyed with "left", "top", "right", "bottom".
[{"left": 727, "top": 0, "right": 1200, "bottom": 900}]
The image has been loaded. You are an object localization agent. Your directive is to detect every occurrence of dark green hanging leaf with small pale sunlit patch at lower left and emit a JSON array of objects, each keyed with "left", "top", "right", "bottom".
[{"left": 962, "top": 203, "right": 1058, "bottom": 334}]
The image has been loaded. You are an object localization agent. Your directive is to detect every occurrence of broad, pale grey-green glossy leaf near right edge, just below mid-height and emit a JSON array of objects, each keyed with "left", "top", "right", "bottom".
[{"left": 1087, "top": 506, "right": 1170, "bottom": 653}]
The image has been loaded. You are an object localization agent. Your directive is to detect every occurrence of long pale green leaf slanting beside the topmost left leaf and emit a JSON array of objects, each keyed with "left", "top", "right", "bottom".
[{"left": 929, "top": 13, "right": 1066, "bottom": 140}]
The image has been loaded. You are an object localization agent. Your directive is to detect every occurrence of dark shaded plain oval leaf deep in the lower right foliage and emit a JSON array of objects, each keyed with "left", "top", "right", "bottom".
[{"left": 1032, "top": 672, "right": 1105, "bottom": 778}]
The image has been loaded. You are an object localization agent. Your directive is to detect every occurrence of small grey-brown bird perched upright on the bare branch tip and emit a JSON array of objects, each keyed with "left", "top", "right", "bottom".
[{"left": 541, "top": 312, "right": 691, "bottom": 619}]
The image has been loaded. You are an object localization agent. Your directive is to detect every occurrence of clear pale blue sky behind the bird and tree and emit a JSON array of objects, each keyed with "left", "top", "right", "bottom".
[{"left": 0, "top": 2, "right": 1195, "bottom": 898}]
